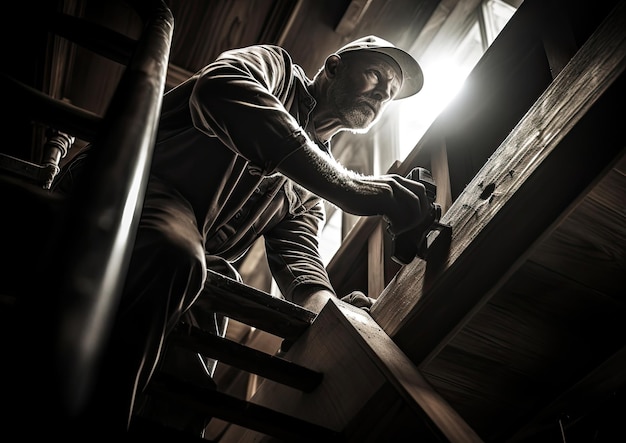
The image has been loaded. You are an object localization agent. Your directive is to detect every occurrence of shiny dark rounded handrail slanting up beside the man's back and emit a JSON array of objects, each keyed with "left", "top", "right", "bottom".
[{"left": 28, "top": 0, "right": 174, "bottom": 417}]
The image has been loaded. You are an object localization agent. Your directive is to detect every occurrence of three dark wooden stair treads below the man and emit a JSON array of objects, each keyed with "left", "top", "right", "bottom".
[{"left": 135, "top": 270, "right": 342, "bottom": 442}]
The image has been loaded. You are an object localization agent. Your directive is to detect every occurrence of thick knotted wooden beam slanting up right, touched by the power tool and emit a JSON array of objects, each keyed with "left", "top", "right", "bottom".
[{"left": 371, "top": 1, "right": 626, "bottom": 364}]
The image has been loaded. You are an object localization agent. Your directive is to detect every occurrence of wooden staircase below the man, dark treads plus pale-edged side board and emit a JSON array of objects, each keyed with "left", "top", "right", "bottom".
[{"left": 131, "top": 271, "right": 480, "bottom": 442}]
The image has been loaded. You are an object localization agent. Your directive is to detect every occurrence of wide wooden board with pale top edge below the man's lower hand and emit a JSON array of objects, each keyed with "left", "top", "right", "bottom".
[{"left": 224, "top": 300, "right": 481, "bottom": 442}]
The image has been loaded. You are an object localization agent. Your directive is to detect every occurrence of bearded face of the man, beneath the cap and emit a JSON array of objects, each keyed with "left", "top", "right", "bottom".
[{"left": 329, "top": 52, "right": 402, "bottom": 132}]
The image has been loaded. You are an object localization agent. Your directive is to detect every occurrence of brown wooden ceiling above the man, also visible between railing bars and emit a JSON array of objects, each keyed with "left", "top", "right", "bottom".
[{"left": 45, "top": 0, "right": 439, "bottom": 119}]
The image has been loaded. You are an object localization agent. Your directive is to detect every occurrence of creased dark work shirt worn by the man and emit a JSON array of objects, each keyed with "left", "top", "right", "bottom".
[{"left": 151, "top": 45, "right": 333, "bottom": 300}]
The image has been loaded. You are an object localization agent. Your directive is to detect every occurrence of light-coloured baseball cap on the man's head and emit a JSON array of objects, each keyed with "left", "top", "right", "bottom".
[{"left": 335, "top": 35, "right": 424, "bottom": 100}]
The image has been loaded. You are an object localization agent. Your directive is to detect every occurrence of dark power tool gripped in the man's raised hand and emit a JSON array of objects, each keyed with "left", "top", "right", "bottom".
[{"left": 387, "top": 167, "right": 452, "bottom": 265}]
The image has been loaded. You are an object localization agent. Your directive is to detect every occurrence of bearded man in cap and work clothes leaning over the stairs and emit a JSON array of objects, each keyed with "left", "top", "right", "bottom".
[{"left": 74, "top": 36, "right": 429, "bottom": 438}]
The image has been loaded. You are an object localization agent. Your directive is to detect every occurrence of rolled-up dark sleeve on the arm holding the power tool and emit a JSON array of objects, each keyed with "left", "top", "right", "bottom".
[{"left": 190, "top": 45, "right": 310, "bottom": 174}]
